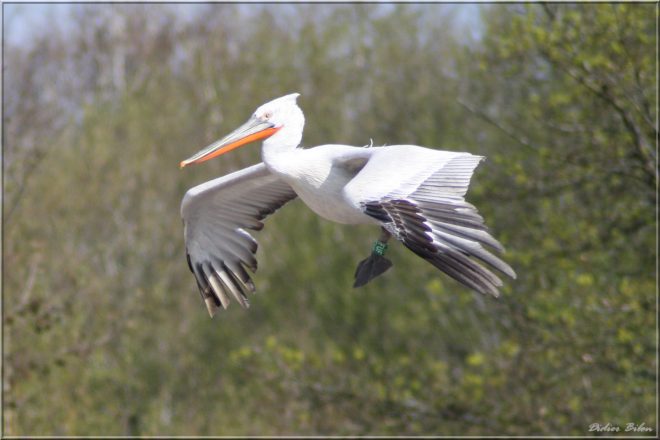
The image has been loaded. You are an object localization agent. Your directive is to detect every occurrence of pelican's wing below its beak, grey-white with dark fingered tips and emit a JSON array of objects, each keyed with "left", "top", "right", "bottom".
[{"left": 181, "top": 163, "right": 296, "bottom": 316}]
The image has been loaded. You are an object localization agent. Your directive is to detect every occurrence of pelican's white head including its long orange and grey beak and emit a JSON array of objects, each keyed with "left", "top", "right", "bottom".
[{"left": 179, "top": 93, "right": 305, "bottom": 168}]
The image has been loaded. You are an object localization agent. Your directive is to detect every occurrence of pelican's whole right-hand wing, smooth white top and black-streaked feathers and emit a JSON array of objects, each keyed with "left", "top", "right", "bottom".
[{"left": 344, "top": 145, "right": 516, "bottom": 296}]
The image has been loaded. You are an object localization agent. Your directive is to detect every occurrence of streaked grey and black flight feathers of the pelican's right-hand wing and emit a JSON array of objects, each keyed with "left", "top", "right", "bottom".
[{"left": 362, "top": 153, "right": 516, "bottom": 297}]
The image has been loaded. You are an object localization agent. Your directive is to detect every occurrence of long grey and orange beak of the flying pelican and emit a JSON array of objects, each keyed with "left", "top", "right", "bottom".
[{"left": 179, "top": 116, "right": 282, "bottom": 168}]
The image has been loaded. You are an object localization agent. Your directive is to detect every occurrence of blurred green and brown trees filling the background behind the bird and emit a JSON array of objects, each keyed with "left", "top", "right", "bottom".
[{"left": 2, "top": 4, "right": 658, "bottom": 435}]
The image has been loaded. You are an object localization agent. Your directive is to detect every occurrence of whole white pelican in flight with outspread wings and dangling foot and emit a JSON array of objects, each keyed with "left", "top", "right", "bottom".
[{"left": 180, "top": 93, "right": 516, "bottom": 317}]
